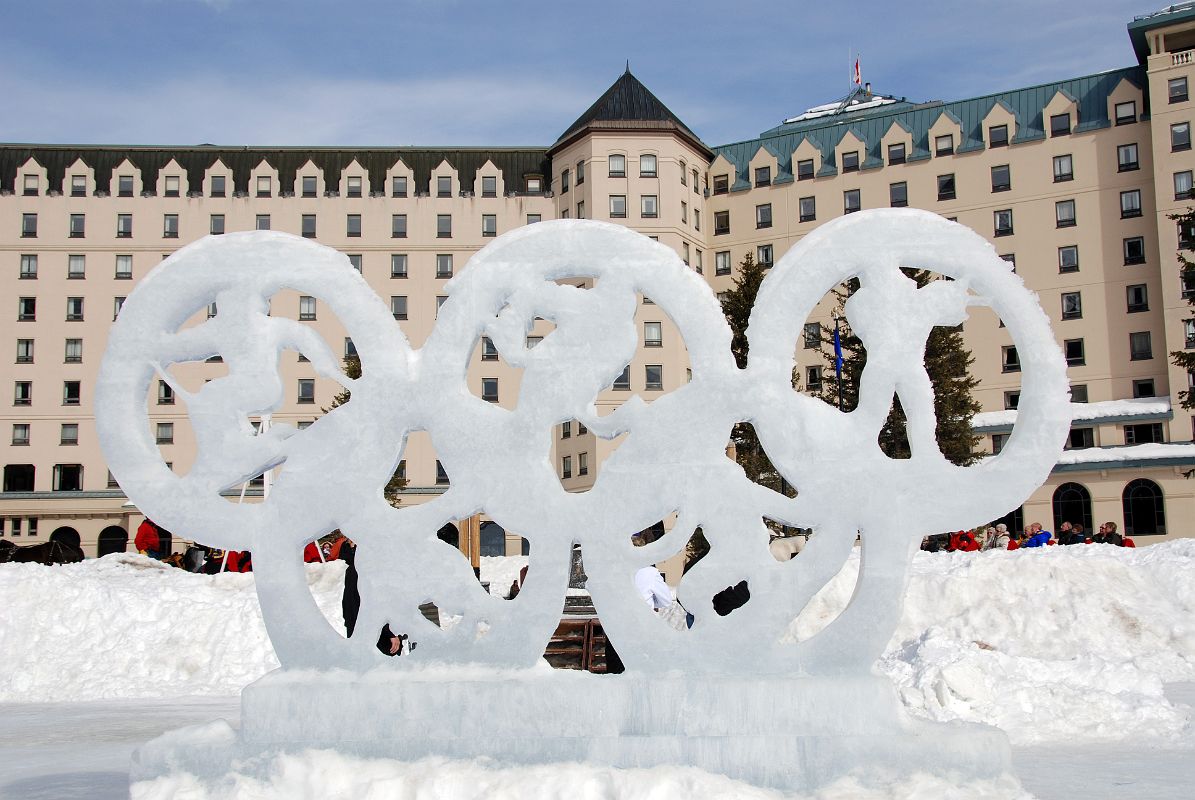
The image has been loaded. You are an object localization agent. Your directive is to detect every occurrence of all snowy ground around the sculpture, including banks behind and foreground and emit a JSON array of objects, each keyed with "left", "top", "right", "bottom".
[{"left": 0, "top": 539, "right": 1195, "bottom": 800}]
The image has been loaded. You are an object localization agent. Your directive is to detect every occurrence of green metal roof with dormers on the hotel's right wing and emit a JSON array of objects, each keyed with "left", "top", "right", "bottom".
[{"left": 713, "top": 66, "right": 1147, "bottom": 191}]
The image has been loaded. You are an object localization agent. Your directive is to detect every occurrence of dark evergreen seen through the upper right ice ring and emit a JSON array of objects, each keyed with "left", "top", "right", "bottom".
[{"left": 820, "top": 269, "right": 981, "bottom": 465}]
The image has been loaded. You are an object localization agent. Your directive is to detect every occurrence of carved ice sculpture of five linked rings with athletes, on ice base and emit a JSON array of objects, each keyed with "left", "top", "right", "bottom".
[{"left": 97, "top": 209, "right": 1070, "bottom": 787}]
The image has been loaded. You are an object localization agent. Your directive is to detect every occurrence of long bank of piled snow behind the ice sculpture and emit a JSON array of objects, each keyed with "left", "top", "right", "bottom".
[{"left": 0, "top": 539, "right": 1195, "bottom": 750}]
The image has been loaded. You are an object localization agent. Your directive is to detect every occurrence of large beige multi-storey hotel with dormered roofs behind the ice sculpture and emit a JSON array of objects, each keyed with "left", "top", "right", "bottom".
[{"left": 0, "top": 4, "right": 1195, "bottom": 560}]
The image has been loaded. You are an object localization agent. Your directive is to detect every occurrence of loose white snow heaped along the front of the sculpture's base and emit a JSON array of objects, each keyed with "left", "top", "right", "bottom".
[{"left": 133, "top": 750, "right": 1030, "bottom": 800}]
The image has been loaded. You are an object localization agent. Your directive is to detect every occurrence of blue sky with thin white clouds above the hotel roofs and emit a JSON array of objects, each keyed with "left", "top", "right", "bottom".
[{"left": 0, "top": 0, "right": 1166, "bottom": 146}]
